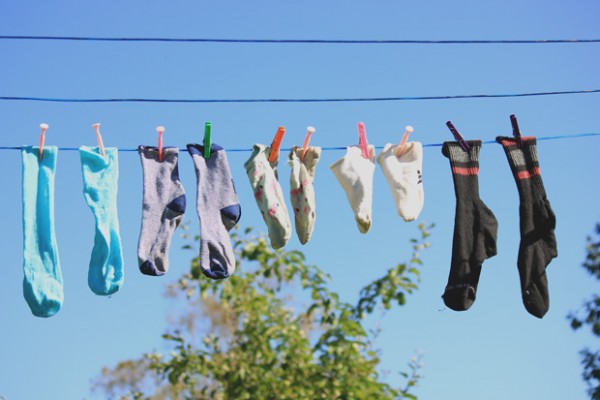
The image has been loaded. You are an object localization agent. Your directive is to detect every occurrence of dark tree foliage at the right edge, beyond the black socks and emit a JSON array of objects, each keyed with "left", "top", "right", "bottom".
[{"left": 568, "top": 223, "right": 600, "bottom": 400}]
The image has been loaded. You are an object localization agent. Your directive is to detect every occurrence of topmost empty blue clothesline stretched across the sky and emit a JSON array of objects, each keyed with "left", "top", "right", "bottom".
[{"left": 0, "top": 35, "right": 600, "bottom": 44}]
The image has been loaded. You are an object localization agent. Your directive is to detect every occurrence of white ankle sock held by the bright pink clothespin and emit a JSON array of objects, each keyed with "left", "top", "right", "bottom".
[{"left": 329, "top": 145, "right": 375, "bottom": 233}]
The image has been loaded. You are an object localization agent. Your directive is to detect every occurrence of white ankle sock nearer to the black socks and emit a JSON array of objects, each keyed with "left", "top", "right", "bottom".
[{"left": 377, "top": 142, "right": 425, "bottom": 222}]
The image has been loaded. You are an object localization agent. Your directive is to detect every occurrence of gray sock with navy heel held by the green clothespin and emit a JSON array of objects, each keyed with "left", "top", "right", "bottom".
[{"left": 187, "top": 144, "right": 242, "bottom": 279}]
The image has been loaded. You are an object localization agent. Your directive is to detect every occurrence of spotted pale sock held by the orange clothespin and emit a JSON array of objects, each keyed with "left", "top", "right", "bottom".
[{"left": 244, "top": 144, "right": 292, "bottom": 249}]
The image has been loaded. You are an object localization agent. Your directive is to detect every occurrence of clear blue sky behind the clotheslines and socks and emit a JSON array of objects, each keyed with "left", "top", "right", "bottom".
[{"left": 0, "top": 0, "right": 600, "bottom": 400}]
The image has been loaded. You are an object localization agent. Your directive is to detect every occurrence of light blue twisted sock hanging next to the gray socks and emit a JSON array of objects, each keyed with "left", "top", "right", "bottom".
[{"left": 79, "top": 146, "right": 123, "bottom": 296}]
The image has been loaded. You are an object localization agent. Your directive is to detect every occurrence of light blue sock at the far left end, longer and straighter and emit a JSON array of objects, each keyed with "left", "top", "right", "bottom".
[{"left": 21, "top": 146, "right": 63, "bottom": 317}]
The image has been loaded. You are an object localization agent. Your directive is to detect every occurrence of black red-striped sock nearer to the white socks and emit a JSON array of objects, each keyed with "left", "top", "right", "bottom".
[{"left": 442, "top": 140, "right": 498, "bottom": 311}]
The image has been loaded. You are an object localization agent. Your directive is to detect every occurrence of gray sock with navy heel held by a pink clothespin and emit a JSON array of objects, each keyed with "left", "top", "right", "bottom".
[{"left": 138, "top": 146, "right": 185, "bottom": 276}]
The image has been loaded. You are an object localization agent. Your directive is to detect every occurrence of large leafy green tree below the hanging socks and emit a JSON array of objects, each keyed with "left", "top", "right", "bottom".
[{"left": 94, "top": 225, "right": 429, "bottom": 400}]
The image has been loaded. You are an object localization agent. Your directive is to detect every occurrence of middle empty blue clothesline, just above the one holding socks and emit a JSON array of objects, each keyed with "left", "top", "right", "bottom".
[{"left": 0, "top": 89, "right": 600, "bottom": 103}]
